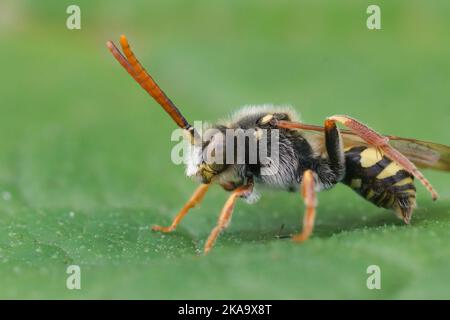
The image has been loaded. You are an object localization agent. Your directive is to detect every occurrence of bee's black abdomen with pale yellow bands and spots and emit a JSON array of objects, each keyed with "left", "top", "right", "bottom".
[{"left": 342, "top": 146, "right": 416, "bottom": 223}]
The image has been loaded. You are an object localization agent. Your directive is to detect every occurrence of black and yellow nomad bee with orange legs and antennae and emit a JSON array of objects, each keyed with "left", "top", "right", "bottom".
[{"left": 107, "top": 36, "right": 450, "bottom": 253}]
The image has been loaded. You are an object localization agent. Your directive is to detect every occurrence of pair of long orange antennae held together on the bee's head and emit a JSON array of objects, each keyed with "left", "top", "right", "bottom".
[{"left": 106, "top": 35, "right": 194, "bottom": 130}]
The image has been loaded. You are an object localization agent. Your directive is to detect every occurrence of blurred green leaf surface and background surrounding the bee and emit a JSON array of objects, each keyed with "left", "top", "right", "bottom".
[{"left": 0, "top": 0, "right": 450, "bottom": 299}]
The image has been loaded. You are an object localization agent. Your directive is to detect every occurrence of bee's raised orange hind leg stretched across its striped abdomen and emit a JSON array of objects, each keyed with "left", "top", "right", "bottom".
[{"left": 327, "top": 115, "right": 438, "bottom": 200}]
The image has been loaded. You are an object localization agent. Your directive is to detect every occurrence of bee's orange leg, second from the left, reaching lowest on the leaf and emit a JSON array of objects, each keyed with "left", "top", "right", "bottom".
[{"left": 204, "top": 184, "right": 253, "bottom": 254}]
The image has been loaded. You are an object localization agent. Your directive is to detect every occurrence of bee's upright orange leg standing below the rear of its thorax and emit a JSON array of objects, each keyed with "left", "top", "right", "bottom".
[{"left": 292, "top": 170, "right": 317, "bottom": 242}]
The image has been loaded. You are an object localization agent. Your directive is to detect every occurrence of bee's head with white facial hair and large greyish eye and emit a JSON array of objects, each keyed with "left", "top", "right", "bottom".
[{"left": 186, "top": 128, "right": 227, "bottom": 183}]
